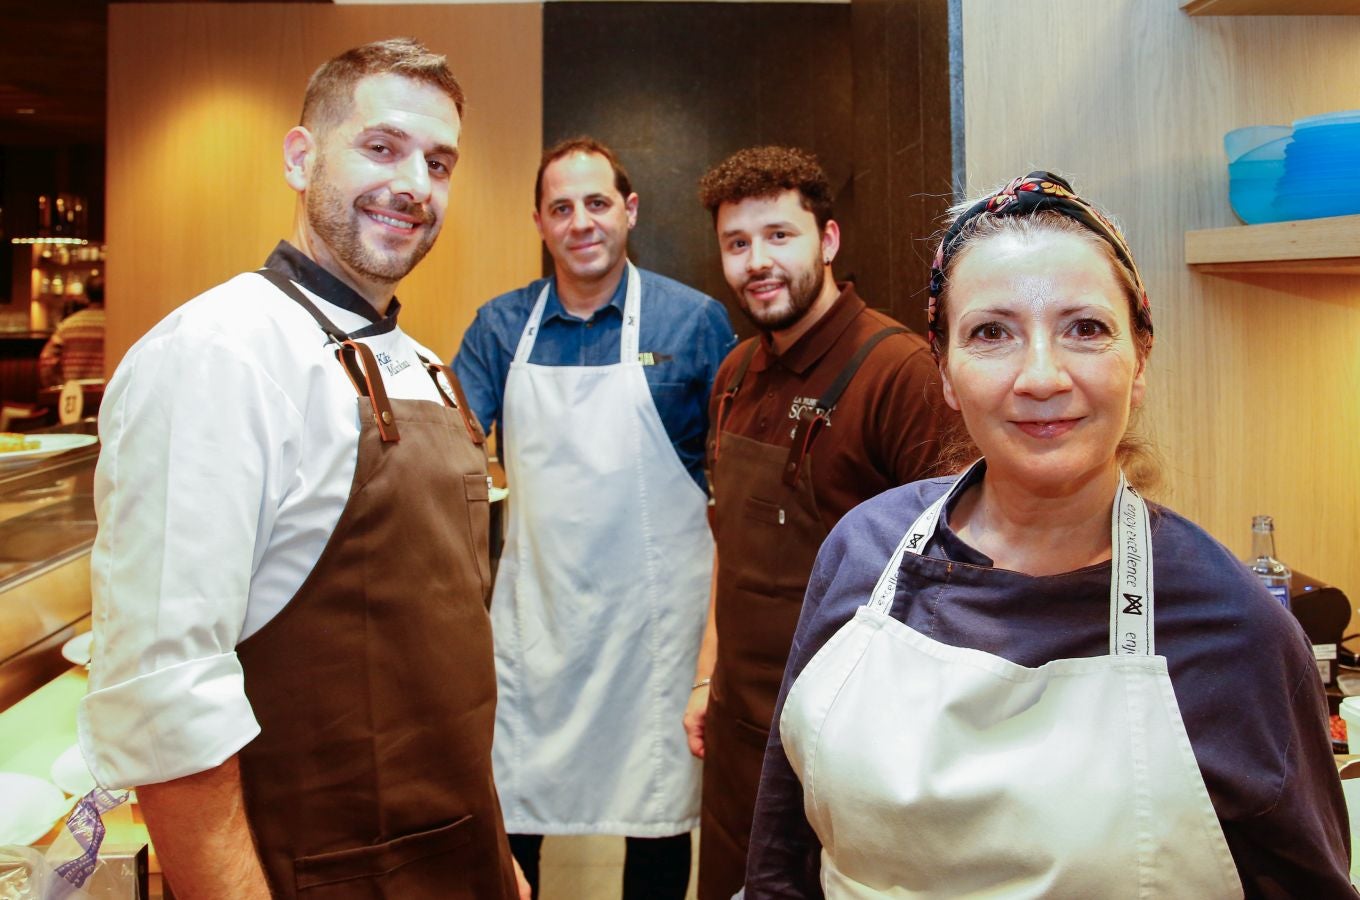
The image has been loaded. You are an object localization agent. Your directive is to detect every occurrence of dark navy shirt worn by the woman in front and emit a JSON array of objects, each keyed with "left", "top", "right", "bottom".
[{"left": 745, "top": 467, "right": 1355, "bottom": 900}]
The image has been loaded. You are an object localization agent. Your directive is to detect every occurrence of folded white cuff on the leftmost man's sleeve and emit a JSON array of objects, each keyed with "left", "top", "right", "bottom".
[{"left": 76, "top": 653, "right": 260, "bottom": 789}]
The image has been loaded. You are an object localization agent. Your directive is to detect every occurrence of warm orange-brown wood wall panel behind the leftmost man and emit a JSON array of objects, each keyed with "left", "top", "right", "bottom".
[{"left": 106, "top": 4, "right": 543, "bottom": 371}]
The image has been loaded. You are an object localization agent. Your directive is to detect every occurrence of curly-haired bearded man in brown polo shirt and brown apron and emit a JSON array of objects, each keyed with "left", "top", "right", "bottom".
[{"left": 684, "top": 147, "right": 952, "bottom": 900}]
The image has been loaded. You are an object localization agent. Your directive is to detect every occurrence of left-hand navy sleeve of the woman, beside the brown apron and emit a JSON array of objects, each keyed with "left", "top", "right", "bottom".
[{"left": 745, "top": 511, "right": 877, "bottom": 900}]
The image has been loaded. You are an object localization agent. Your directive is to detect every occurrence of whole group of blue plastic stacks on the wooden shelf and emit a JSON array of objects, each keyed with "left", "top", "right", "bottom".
[{"left": 1223, "top": 110, "right": 1360, "bottom": 224}]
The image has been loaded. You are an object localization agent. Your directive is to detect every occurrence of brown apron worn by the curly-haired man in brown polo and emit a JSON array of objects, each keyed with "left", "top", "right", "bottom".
[{"left": 699, "top": 328, "right": 904, "bottom": 900}]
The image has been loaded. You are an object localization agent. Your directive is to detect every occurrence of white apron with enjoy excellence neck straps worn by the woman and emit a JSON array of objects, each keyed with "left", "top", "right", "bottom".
[{"left": 779, "top": 464, "right": 1242, "bottom": 900}]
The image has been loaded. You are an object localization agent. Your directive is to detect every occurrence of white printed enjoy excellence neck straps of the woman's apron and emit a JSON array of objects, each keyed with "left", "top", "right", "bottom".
[{"left": 865, "top": 460, "right": 1156, "bottom": 657}]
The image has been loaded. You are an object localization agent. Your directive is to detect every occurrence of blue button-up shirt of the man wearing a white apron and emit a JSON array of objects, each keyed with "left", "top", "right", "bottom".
[{"left": 453, "top": 269, "right": 737, "bottom": 491}]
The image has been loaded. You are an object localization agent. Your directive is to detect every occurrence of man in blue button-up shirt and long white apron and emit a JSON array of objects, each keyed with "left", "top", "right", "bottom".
[{"left": 453, "top": 139, "right": 734, "bottom": 900}]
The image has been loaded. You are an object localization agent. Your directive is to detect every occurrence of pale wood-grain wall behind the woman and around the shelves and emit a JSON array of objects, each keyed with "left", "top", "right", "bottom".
[{"left": 963, "top": 0, "right": 1360, "bottom": 602}]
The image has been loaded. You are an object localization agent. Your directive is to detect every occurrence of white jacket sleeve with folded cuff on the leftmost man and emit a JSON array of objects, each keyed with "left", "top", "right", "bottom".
[{"left": 78, "top": 325, "right": 302, "bottom": 787}]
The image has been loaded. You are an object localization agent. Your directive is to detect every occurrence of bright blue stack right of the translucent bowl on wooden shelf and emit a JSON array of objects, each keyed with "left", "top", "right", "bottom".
[{"left": 1272, "top": 110, "right": 1360, "bottom": 219}]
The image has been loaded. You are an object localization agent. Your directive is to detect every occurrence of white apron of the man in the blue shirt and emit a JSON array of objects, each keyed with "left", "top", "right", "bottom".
[{"left": 491, "top": 262, "right": 713, "bottom": 837}]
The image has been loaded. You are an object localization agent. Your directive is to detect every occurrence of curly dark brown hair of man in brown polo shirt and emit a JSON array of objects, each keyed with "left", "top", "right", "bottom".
[{"left": 699, "top": 147, "right": 832, "bottom": 228}]
